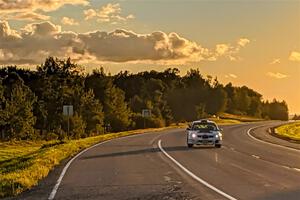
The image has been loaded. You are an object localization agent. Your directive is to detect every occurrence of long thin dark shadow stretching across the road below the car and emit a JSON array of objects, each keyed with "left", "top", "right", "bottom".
[{"left": 80, "top": 146, "right": 213, "bottom": 160}]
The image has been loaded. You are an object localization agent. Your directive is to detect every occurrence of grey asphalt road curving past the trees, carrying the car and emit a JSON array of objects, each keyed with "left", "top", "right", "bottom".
[{"left": 12, "top": 122, "right": 300, "bottom": 200}]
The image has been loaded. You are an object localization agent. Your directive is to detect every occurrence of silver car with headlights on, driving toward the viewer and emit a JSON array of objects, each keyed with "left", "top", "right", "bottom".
[{"left": 187, "top": 119, "right": 223, "bottom": 148}]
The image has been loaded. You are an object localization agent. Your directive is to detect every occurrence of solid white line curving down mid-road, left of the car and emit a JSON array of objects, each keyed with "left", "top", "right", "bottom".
[{"left": 158, "top": 140, "right": 237, "bottom": 200}]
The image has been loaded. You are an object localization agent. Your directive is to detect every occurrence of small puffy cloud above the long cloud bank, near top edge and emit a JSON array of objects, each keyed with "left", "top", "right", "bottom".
[{"left": 83, "top": 3, "right": 135, "bottom": 24}]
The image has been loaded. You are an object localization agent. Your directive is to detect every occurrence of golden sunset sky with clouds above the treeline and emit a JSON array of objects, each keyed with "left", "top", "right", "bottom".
[{"left": 0, "top": 0, "right": 300, "bottom": 114}]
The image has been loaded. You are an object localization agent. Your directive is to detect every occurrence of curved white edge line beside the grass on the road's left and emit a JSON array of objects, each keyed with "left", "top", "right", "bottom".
[{"left": 48, "top": 130, "right": 180, "bottom": 200}]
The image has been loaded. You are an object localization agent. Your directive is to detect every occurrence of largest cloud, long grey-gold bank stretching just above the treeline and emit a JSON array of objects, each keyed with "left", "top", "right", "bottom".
[{"left": 0, "top": 21, "right": 251, "bottom": 64}]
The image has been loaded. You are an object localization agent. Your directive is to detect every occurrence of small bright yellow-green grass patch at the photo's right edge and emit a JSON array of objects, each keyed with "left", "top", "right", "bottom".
[{"left": 276, "top": 121, "right": 300, "bottom": 141}]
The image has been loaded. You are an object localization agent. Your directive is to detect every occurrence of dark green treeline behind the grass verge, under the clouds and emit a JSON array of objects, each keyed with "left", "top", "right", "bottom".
[{"left": 0, "top": 57, "right": 288, "bottom": 140}]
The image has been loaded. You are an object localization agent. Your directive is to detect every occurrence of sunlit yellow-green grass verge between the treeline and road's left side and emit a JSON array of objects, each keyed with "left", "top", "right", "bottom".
[{"left": 0, "top": 118, "right": 240, "bottom": 198}]
